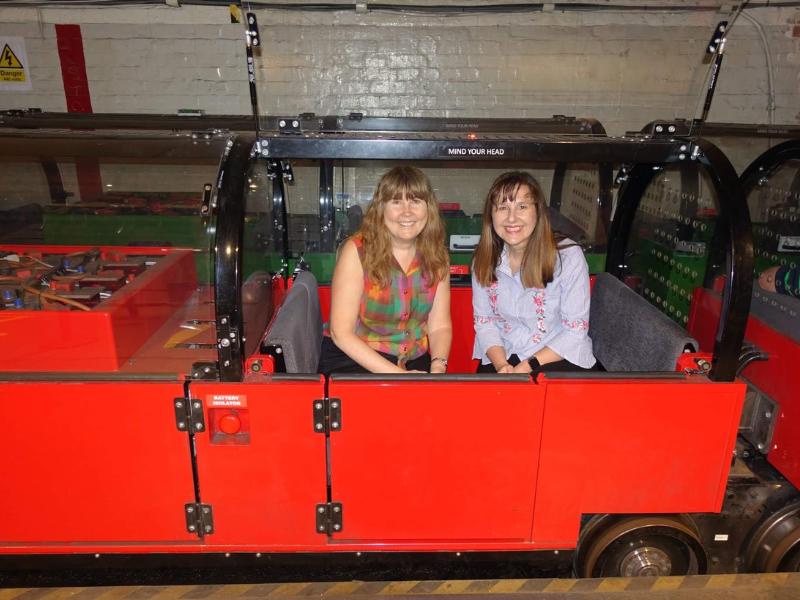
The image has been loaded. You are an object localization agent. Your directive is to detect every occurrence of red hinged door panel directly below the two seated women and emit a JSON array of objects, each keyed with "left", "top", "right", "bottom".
[{"left": 329, "top": 377, "right": 544, "bottom": 549}]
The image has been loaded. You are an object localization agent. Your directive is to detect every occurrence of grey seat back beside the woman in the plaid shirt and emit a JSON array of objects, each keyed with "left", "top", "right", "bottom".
[{"left": 264, "top": 271, "right": 322, "bottom": 373}]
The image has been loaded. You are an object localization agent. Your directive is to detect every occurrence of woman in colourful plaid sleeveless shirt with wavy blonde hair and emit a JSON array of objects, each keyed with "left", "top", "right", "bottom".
[{"left": 319, "top": 166, "right": 452, "bottom": 373}]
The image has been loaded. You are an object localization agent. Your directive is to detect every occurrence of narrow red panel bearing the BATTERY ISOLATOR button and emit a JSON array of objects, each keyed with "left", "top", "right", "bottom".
[{"left": 191, "top": 377, "right": 327, "bottom": 551}]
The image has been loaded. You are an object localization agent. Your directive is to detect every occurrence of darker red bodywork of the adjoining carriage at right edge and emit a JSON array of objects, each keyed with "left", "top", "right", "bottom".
[{"left": 687, "top": 289, "right": 800, "bottom": 487}]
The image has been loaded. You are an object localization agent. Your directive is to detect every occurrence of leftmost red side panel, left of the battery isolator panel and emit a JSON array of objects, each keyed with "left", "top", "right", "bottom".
[{"left": 0, "top": 383, "right": 198, "bottom": 553}]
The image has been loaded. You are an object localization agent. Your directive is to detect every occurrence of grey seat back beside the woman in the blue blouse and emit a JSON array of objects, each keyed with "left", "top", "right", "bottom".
[{"left": 589, "top": 273, "right": 699, "bottom": 371}]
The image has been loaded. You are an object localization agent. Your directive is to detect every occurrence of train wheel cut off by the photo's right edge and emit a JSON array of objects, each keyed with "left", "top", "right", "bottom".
[{"left": 747, "top": 503, "right": 800, "bottom": 573}]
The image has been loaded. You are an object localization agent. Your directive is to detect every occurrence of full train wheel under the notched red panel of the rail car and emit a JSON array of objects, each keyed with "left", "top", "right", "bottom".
[{"left": 578, "top": 517, "right": 706, "bottom": 577}]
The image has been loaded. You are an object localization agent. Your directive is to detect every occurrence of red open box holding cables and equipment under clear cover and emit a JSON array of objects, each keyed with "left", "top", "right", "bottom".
[{"left": 0, "top": 246, "right": 197, "bottom": 372}]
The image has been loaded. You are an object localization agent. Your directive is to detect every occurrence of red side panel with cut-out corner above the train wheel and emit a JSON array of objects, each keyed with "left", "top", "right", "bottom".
[{"left": 533, "top": 376, "right": 745, "bottom": 544}]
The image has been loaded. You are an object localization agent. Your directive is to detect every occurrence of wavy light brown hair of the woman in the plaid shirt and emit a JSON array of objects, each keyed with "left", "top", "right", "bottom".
[{"left": 356, "top": 166, "right": 449, "bottom": 286}]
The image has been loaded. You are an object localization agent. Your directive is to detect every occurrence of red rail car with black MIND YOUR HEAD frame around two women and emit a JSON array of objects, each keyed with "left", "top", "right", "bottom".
[{"left": 0, "top": 123, "right": 797, "bottom": 576}]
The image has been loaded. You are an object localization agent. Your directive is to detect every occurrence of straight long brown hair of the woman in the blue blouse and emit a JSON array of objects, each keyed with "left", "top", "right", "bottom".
[{"left": 472, "top": 171, "right": 561, "bottom": 288}]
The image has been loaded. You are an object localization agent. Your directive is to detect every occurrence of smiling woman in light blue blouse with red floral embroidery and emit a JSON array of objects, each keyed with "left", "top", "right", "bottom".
[{"left": 472, "top": 171, "right": 596, "bottom": 375}]
